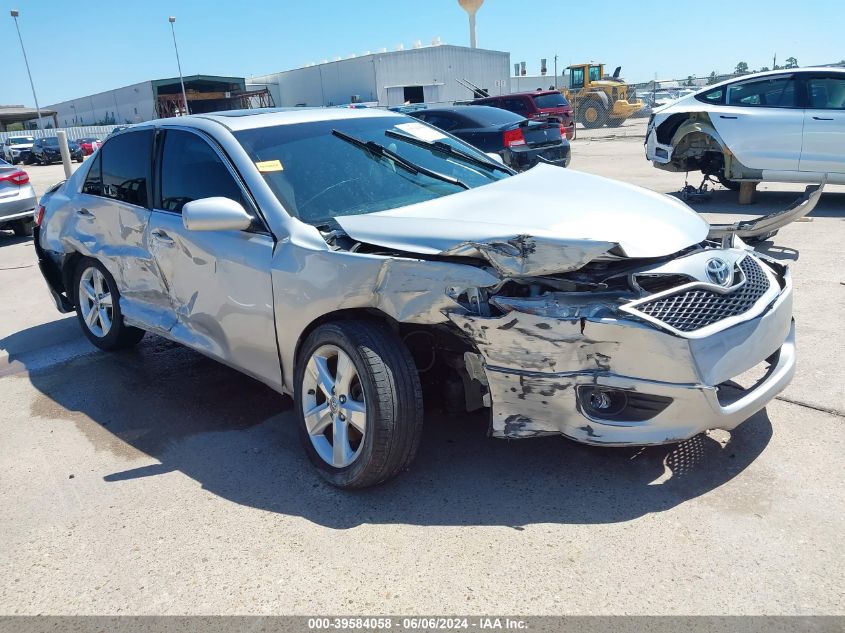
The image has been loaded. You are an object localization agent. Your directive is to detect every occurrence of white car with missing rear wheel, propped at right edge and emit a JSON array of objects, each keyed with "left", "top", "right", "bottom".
[{"left": 646, "top": 68, "right": 845, "bottom": 189}]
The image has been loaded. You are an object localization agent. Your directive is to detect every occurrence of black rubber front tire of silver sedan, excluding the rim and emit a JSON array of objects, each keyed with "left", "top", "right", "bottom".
[{"left": 294, "top": 321, "right": 423, "bottom": 489}]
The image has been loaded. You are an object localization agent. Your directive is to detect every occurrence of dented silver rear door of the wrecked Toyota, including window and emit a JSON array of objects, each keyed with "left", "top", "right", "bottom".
[{"left": 75, "top": 128, "right": 175, "bottom": 332}]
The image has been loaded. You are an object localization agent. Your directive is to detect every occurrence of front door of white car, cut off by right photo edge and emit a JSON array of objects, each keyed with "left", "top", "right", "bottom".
[{"left": 800, "top": 73, "right": 845, "bottom": 174}]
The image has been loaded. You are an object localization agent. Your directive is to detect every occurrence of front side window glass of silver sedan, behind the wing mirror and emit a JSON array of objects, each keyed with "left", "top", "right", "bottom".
[{"left": 157, "top": 130, "right": 249, "bottom": 213}]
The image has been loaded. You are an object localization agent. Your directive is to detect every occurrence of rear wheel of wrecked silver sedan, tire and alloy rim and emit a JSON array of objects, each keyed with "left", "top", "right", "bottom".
[{"left": 73, "top": 257, "right": 144, "bottom": 351}]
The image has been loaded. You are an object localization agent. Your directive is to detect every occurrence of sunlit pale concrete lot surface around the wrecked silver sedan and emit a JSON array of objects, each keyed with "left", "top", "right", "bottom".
[{"left": 0, "top": 126, "right": 845, "bottom": 615}]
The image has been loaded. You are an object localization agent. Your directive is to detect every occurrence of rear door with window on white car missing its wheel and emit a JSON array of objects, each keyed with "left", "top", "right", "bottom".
[{"left": 710, "top": 73, "right": 804, "bottom": 171}]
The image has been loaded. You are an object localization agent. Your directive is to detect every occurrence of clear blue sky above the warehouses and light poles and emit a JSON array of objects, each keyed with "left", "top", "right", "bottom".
[{"left": 0, "top": 0, "right": 845, "bottom": 106}]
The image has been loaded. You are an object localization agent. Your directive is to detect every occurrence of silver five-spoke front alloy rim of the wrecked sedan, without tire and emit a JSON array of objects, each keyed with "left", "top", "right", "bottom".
[{"left": 302, "top": 345, "right": 367, "bottom": 468}]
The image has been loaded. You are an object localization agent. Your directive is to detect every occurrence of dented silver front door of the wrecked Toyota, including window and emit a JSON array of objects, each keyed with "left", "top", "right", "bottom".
[{"left": 148, "top": 128, "right": 282, "bottom": 388}]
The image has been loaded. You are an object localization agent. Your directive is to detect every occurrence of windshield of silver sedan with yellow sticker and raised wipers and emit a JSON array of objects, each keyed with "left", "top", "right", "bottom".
[{"left": 235, "top": 117, "right": 508, "bottom": 226}]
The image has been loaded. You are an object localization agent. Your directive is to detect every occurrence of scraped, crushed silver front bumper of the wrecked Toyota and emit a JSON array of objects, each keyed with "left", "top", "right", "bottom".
[{"left": 450, "top": 256, "right": 795, "bottom": 446}]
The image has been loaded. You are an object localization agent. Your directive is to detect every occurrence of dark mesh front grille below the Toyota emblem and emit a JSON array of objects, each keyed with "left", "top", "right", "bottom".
[{"left": 634, "top": 257, "right": 769, "bottom": 332}]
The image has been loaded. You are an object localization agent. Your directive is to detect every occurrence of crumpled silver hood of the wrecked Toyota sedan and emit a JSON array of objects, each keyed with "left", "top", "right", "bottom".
[{"left": 336, "top": 164, "right": 708, "bottom": 276}]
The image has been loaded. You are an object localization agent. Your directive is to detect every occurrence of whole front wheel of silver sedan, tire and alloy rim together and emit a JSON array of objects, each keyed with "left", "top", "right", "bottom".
[{"left": 294, "top": 321, "right": 423, "bottom": 489}]
